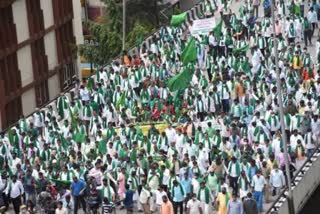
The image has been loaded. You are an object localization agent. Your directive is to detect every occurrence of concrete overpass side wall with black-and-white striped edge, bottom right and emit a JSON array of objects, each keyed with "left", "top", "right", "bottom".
[{"left": 266, "top": 148, "right": 320, "bottom": 214}]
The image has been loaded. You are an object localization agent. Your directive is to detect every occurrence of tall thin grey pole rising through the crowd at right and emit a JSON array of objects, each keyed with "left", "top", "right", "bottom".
[{"left": 270, "top": 0, "right": 295, "bottom": 213}]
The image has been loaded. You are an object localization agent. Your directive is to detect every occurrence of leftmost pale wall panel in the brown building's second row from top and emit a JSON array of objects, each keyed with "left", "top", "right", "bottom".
[{"left": 17, "top": 45, "right": 33, "bottom": 87}]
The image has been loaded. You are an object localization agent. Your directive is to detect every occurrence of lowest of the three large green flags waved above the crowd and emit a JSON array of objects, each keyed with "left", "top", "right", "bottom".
[{"left": 168, "top": 68, "right": 193, "bottom": 91}]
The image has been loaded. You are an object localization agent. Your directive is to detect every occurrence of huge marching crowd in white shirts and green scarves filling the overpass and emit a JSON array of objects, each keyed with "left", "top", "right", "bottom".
[{"left": 0, "top": 0, "right": 320, "bottom": 214}]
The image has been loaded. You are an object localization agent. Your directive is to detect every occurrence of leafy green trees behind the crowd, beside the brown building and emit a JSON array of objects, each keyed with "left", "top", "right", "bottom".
[{"left": 77, "top": 0, "right": 162, "bottom": 66}]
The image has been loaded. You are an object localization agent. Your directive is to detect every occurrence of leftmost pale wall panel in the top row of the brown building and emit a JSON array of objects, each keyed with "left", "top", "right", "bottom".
[{"left": 12, "top": 0, "right": 29, "bottom": 43}]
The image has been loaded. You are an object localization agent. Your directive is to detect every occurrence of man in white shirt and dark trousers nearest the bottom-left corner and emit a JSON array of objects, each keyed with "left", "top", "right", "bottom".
[{"left": 7, "top": 175, "right": 24, "bottom": 213}]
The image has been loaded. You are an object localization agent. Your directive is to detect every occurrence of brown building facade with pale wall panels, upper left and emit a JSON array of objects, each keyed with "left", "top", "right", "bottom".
[{"left": 0, "top": 0, "right": 83, "bottom": 129}]
